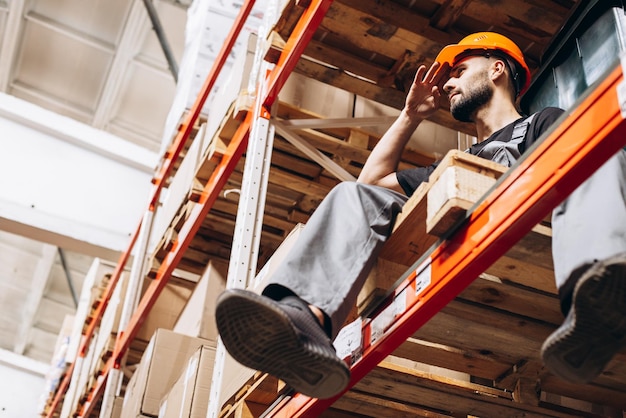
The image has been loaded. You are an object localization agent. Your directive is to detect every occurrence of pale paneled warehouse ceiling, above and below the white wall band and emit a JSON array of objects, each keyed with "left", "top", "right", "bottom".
[{"left": 0, "top": 0, "right": 191, "bottom": 363}]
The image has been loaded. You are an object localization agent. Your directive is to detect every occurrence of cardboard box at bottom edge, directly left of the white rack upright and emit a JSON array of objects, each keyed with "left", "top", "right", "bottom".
[{"left": 159, "top": 346, "right": 215, "bottom": 418}]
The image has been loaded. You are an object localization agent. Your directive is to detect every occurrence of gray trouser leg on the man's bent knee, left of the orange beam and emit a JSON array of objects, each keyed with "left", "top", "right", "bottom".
[{"left": 263, "top": 182, "right": 408, "bottom": 338}]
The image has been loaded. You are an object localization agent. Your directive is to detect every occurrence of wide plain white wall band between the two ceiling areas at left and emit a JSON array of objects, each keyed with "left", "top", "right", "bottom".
[{"left": 0, "top": 94, "right": 157, "bottom": 259}]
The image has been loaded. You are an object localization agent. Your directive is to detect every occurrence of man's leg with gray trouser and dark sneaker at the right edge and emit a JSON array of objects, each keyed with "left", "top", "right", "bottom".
[{"left": 542, "top": 151, "right": 626, "bottom": 383}]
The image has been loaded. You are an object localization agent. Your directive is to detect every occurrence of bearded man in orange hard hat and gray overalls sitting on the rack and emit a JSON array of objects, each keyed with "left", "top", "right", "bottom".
[{"left": 216, "top": 32, "right": 626, "bottom": 398}]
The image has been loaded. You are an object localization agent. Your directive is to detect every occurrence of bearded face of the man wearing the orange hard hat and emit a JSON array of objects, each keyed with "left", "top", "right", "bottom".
[{"left": 443, "top": 56, "right": 493, "bottom": 122}]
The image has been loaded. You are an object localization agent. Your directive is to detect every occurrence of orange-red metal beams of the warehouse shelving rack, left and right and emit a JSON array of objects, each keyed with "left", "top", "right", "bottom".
[{"left": 49, "top": 0, "right": 626, "bottom": 417}]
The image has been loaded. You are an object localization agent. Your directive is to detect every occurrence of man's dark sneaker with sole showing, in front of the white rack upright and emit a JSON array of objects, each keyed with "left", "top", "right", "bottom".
[{"left": 215, "top": 289, "right": 350, "bottom": 398}]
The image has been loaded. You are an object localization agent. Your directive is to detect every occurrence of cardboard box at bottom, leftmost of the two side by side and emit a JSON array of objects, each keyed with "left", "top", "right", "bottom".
[{"left": 122, "top": 329, "right": 211, "bottom": 418}]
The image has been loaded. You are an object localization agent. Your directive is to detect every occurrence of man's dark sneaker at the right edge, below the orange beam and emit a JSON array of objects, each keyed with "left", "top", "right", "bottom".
[{"left": 541, "top": 254, "right": 626, "bottom": 383}]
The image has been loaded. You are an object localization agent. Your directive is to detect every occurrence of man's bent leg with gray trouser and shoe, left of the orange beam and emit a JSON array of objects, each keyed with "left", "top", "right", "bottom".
[{"left": 216, "top": 183, "right": 407, "bottom": 398}]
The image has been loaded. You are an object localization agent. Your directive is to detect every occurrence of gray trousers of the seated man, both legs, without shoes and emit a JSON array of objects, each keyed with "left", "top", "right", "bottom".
[{"left": 263, "top": 151, "right": 626, "bottom": 338}]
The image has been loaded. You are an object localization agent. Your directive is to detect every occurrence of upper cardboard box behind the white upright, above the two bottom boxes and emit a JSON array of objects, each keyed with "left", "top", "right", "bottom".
[{"left": 173, "top": 262, "right": 226, "bottom": 341}]
